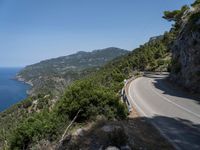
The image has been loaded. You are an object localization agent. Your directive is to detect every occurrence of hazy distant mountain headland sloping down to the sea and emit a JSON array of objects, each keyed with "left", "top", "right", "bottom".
[{"left": 17, "top": 47, "right": 129, "bottom": 94}]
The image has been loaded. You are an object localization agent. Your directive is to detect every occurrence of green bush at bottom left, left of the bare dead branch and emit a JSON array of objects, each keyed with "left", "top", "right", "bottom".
[{"left": 9, "top": 111, "right": 63, "bottom": 150}]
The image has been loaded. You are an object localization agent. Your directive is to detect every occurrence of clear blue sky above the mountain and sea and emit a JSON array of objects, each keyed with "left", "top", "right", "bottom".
[{"left": 0, "top": 0, "right": 193, "bottom": 67}]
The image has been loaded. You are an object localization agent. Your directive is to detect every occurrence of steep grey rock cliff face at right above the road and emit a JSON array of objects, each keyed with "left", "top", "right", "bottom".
[{"left": 171, "top": 7, "right": 200, "bottom": 93}]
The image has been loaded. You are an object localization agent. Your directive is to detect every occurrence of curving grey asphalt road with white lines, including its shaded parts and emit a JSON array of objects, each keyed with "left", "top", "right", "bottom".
[{"left": 128, "top": 74, "right": 200, "bottom": 150}]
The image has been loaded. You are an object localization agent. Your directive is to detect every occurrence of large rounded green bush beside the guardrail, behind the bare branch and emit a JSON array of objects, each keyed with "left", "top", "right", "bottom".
[{"left": 57, "top": 79, "right": 127, "bottom": 121}]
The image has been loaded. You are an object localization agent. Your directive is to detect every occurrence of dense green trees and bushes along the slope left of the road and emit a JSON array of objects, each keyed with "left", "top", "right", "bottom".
[{"left": 1, "top": 30, "right": 170, "bottom": 149}]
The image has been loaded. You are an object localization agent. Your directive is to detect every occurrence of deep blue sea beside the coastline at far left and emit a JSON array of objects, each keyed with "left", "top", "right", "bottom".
[{"left": 0, "top": 68, "right": 30, "bottom": 112}]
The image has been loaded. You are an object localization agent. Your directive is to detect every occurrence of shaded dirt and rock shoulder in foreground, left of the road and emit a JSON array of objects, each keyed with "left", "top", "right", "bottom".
[{"left": 58, "top": 113, "right": 174, "bottom": 150}]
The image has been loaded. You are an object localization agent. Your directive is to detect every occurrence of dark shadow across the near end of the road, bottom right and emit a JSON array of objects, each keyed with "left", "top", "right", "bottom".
[{"left": 151, "top": 116, "right": 200, "bottom": 150}]
